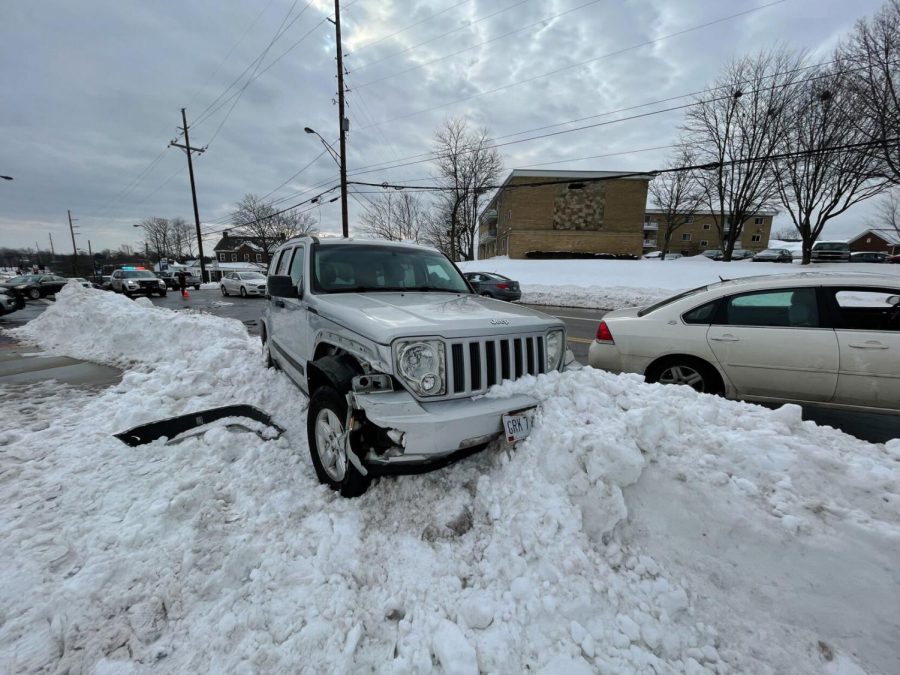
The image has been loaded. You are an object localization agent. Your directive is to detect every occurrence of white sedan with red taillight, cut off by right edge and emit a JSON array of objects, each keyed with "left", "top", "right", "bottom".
[{"left": 589, "top": 272, "right": 900, "bottom": 411}]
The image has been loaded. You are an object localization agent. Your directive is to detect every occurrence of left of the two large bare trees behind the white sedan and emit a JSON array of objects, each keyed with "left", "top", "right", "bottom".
[{"left": 684, "top": 48, "right": 803, "bottom": 260}]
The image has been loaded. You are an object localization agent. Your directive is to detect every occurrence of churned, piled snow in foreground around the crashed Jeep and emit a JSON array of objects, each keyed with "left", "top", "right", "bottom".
[{"left": 0, "top": 286, "right": 900, "bottom": 675}]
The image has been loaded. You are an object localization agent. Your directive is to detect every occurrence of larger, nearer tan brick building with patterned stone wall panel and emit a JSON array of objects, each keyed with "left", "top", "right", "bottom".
[{"left": 478, "top": 169, "right": 653, "bottom": 259}]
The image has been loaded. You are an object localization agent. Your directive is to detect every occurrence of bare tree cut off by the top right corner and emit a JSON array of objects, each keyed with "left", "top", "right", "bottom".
[{"left": 839, "top": 0, "right": 900, "bottom": 184}]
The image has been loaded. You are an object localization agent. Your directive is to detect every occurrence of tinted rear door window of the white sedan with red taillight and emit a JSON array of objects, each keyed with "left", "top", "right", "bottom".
[{"left": 723, "top": 288, "right": 819, "bottom": 328}]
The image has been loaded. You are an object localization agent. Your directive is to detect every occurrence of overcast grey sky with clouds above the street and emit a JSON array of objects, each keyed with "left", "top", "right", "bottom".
[{"left": 0, "top": 0, "right": 881, "bottom": 251}]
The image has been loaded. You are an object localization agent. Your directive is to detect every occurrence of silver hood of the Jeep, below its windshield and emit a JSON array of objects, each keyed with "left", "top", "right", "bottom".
[{"left": 314, "top": 293, "right": 563, "bottom": 344}]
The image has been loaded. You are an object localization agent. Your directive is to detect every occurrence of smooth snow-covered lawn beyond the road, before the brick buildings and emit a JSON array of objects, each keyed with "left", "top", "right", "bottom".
[{"left": 459, "top": 250, "right": 900, "bottom": 309}]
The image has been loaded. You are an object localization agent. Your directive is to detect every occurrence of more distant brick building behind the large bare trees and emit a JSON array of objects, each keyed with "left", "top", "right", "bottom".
[{"left": 643, "top": 209, "right": 775, "bottom": 255}]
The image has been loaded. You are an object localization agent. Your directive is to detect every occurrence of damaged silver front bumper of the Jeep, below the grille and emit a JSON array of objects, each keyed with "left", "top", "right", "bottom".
[{"left": 348, "top": 391, "right": 538, "bottom": 472}]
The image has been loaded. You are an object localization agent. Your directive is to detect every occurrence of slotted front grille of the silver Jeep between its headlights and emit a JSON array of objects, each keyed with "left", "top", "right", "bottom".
[{"left": 447, "top": 334, "right": 547, "bottom": 396}]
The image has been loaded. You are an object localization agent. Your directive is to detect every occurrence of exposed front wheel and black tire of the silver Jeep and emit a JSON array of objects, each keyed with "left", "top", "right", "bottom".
[{"left": 306, "top": 386, "right": 371, "bottom": 497}]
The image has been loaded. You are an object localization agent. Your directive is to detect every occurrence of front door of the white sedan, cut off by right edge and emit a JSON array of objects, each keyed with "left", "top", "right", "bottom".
[{"left": 824, "top": 287, "right": 900, "bottom": 410}]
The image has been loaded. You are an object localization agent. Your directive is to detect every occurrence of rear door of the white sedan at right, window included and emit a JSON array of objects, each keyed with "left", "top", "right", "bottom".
[{"left": 707, "top": 287, "right": 839, "bottom": 401}]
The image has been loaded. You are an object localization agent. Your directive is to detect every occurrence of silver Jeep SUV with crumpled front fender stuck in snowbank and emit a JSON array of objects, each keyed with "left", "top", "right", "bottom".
[{"left": 261, "top": 237, "right": 577, "bottom": 497}]
